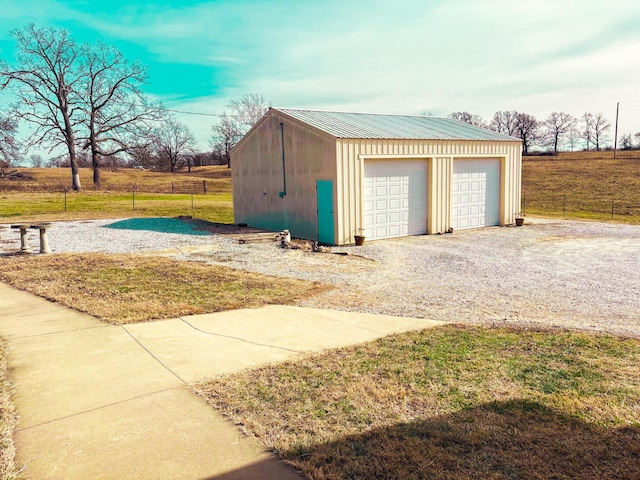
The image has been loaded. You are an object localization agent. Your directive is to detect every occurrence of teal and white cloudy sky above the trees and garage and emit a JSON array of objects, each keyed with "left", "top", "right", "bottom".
[{"left": 0, "top": 0, "right": 640, "bottom": 149}]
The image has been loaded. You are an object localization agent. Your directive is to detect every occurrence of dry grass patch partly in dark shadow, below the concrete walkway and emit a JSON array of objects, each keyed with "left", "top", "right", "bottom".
[{"left": 196, "top": 326, "right": 640, "bottom": 479}]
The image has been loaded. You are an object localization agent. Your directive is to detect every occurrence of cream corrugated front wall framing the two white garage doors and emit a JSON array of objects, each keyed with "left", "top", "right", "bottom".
[{"left": 336, "top": 139, "right": 522, "bottom": 244}]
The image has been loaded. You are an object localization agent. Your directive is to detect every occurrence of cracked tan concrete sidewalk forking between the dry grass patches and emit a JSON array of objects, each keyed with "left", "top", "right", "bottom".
[{"left": 0, "top": 284, "right": 448, "bottom": 480}]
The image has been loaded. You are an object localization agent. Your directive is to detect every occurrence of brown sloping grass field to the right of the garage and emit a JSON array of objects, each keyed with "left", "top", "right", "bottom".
[{"left": 522, "top": 150, "right": 640, "bottom": 224}]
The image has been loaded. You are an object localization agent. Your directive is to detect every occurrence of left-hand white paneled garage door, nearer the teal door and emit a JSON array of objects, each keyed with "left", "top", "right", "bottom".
[{"left": 364, "top": 160, "right": 427, "bottom": 239}]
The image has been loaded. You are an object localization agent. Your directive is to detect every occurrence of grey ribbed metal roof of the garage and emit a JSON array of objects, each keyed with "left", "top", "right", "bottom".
[{"left": 273, "top": 108, "right": 520, "bottom": 142}]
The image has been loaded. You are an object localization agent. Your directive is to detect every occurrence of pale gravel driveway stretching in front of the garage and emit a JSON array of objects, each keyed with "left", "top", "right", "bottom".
[{"left": 0, "top": 220, "right": 640, "bottom": 337}]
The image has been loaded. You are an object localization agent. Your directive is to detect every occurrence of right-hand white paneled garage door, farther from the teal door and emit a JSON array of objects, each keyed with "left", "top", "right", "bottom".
[{"left": 451, "top": 158, "right": 500, "bottom": 230}]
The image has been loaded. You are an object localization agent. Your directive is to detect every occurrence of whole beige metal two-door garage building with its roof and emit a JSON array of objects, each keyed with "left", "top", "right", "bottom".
[{"left": 231, "top": 108, "right": 522, "bottom": 245}]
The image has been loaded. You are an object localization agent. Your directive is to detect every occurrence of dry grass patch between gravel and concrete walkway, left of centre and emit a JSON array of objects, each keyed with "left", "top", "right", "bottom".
[{"left": 0, "top": 254, "right": 329, "bottom": 324}]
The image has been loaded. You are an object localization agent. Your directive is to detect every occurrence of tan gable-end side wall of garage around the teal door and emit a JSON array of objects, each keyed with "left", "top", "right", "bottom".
[{"left": 231, "top": 113, "right": 337, "bottom": 239}]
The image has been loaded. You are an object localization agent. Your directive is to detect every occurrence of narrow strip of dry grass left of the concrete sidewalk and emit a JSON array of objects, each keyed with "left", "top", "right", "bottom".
[{"left": 0, "top": 341, "right": 17, "bottom": 480}]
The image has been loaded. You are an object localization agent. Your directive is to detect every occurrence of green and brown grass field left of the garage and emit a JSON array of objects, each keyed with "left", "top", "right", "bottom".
[{"left": 0, "top": 167, "right": 233, "bottom": 223}]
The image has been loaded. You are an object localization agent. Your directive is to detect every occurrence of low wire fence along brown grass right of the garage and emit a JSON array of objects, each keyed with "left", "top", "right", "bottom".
[{"left": 521, "top": 193, "right": 640, "bottom": 222}]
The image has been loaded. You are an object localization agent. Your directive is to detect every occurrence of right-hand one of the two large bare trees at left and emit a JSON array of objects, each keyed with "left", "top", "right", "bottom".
[{"left": 81, "top": 43, "right": 160, "bottom": 186}]
